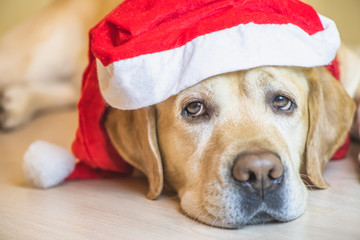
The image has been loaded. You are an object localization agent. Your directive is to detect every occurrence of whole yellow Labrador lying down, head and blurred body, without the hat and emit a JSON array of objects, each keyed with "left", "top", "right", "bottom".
[{"left": 0, "top": 0, "right": 360, "bottom": 228}]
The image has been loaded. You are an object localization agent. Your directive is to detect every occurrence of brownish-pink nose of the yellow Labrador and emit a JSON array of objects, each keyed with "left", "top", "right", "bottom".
[{"left": 232, "top": 152, "right": 284, "bottom": 197}]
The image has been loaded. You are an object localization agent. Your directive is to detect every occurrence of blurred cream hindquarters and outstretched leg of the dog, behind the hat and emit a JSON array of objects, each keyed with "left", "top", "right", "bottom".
[{"left": 0, "top": 0, "right": 121, "bottom": 130}]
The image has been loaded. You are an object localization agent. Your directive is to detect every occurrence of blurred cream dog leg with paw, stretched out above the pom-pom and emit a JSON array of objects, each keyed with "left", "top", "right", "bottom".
[{"left": 0, "top": 82, "right": 78, "bottom": 129}]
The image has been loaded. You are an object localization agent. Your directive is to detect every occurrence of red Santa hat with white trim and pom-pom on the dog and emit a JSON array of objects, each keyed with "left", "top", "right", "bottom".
[{"left": 25, "top": 0, "right": 340, "bottom": 187}]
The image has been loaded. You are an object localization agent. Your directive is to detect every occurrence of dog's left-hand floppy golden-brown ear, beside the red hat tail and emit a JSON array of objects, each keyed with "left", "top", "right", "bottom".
[{"left": 105, "top": 107, "right": 163, "bottom": 199}]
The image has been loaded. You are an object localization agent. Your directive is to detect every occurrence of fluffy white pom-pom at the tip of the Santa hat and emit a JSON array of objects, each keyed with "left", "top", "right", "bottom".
[{"left": 24, "top": 141, "right": 76, "bottom": 188}]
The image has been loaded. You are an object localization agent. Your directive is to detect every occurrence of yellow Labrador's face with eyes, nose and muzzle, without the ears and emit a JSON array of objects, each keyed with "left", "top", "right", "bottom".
[{"left": 157, "top": 68, "right": 309, "bottom": 227}]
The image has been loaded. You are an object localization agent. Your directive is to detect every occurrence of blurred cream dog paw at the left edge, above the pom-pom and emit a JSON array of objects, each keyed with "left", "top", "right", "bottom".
[{"left": 0, "top": 86, "right": 32, "bottom": 130}]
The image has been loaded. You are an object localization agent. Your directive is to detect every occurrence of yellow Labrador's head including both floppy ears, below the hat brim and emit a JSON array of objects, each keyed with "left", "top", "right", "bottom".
[{"left": 106, "top": 67, "right": 355, "bottom": 228}]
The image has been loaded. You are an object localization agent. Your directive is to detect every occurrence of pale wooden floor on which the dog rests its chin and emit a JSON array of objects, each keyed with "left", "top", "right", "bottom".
[{"left": 0, "top": 110, "right": 360, "bottom": 240}]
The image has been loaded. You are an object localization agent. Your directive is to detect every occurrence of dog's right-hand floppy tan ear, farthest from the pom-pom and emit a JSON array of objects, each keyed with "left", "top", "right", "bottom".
[{"left": 305, "top": 67, "right": 355, "bottom": 188}]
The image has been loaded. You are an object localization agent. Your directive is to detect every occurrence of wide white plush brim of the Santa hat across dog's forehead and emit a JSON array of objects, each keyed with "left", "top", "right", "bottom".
[{"left": 97, "top": 16, "right": 340, "bottom": 110}]
